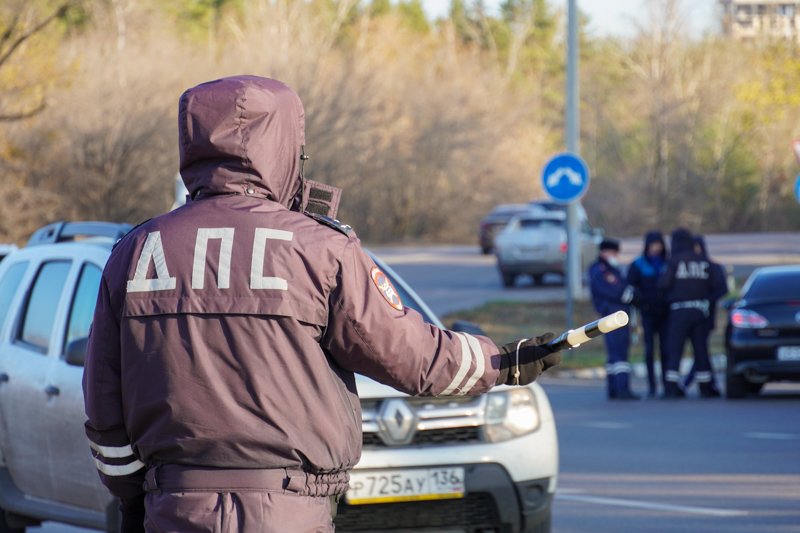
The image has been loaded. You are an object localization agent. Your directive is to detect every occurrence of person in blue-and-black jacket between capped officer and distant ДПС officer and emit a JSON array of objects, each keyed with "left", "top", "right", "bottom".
[{"left": 627, "top": 231, "right": 669, "bottom": 397}]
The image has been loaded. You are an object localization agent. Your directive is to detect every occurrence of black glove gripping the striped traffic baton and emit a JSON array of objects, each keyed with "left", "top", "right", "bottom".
[{"left": 496, "top": 333, "right": 561, "bottom": 385}]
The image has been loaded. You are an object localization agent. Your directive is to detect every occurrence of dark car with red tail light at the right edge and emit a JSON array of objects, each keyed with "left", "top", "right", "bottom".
[{"left": 725, "top": 265, "right": 800, "bottom": 398}]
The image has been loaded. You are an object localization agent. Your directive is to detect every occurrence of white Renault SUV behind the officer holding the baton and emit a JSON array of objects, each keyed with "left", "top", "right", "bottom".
[{"left": 0, "top": 223, "right": 558, "bottom": 533}]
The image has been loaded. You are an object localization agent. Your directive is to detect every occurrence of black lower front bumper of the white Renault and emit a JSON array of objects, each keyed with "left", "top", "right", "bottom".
[{"left": 336, "top": 463, "right": 553, "bottom": 533}]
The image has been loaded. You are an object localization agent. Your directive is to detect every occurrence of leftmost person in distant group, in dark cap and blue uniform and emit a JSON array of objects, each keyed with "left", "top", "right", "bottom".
[{"left": 589, "top": 239, "right": 639, "bottom": 400}]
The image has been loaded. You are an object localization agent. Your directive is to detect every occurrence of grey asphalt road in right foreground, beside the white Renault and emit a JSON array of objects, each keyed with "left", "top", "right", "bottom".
[{"left": 541, "top": 378, "right": 800, "bottom": 533}]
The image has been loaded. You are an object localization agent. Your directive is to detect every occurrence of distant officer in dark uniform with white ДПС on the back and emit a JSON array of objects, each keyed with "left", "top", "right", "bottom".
[{"left": 661, "top": 228, "right": 719, "bottom": 398}]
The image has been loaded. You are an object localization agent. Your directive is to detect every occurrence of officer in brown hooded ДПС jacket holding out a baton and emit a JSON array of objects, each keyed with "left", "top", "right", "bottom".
[{"left": 83, "top": 76, "right": 561, "bottom": 533}]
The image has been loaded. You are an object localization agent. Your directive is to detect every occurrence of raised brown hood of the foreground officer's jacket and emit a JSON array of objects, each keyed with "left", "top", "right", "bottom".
[{"left": 178, "top": 76, "right": 305, "bottom": 207}]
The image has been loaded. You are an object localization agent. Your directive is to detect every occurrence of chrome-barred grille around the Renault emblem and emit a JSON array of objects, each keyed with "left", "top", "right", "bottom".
[{"left": 361, "top": 396, "right": 486, "bottom": 448}]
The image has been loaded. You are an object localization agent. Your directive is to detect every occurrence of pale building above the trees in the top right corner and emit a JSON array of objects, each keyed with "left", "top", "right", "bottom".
[{"left": 719, "top": 0, "right": 800, "bottom": 43}]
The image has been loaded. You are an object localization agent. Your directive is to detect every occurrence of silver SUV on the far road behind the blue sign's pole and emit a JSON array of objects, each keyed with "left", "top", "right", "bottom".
[{"left": 494, "top": 209, "right": 602, "bottom": 287}]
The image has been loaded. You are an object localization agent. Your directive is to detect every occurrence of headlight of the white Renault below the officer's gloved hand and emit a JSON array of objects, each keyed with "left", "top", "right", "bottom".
[{"left": 485, "top": 388, "right": 540, "bottom": 442}]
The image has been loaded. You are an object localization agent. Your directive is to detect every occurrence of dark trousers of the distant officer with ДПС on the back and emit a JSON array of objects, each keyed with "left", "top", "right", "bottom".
[{"left": 664, "top": 309, "right": 713, "bottom": 394}]
